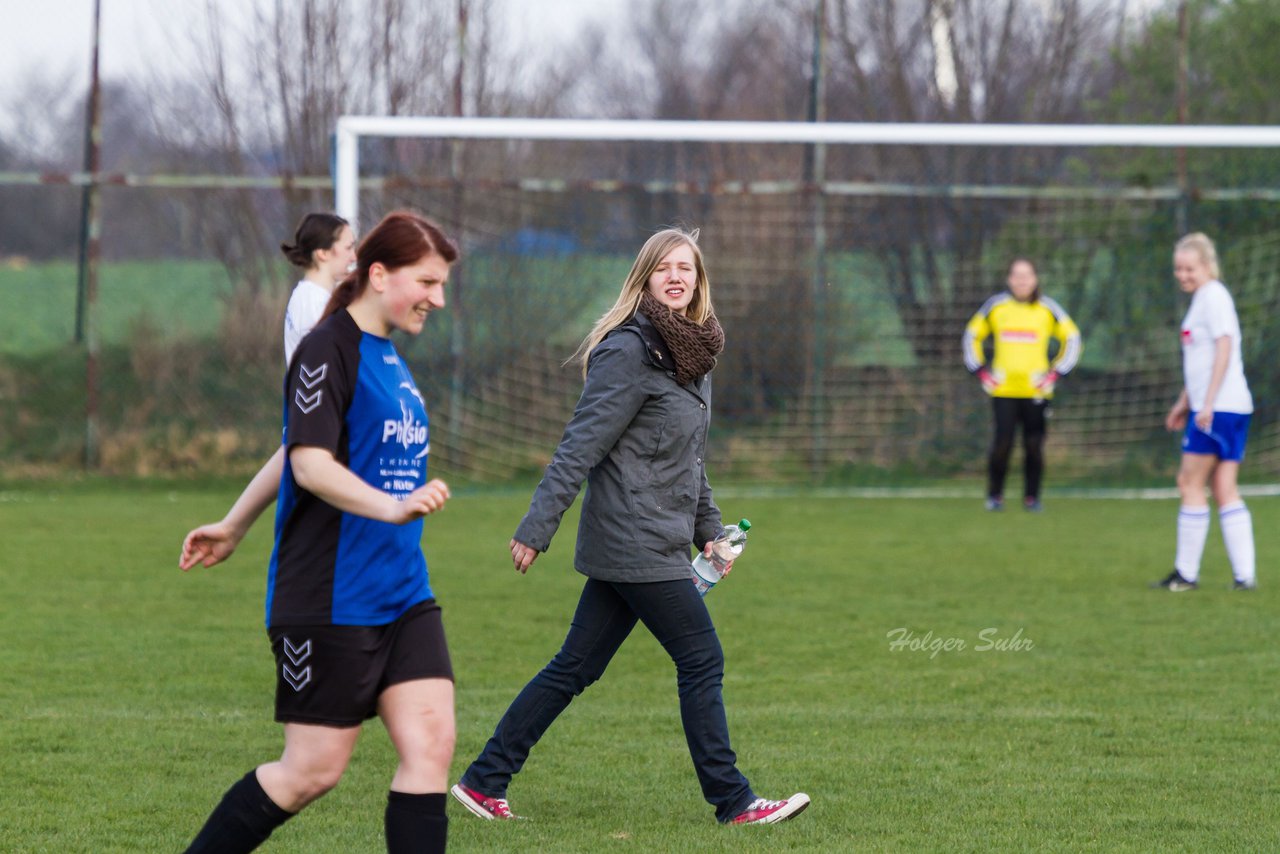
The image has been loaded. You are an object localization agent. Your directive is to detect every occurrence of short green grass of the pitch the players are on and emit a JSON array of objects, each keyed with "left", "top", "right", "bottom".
[{"left": 0, "top": 484, "right": 1280, "bottom": 854}]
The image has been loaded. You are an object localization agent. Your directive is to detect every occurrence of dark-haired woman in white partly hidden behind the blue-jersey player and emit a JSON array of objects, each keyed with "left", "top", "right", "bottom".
[{"left": 280, "top": 214, "right": 356, "bottom": 364}]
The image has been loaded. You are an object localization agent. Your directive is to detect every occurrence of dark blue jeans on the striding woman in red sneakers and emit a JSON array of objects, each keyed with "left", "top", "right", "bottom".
[{"left": 462, "top": 579, "right": 755, "bottom": 822}]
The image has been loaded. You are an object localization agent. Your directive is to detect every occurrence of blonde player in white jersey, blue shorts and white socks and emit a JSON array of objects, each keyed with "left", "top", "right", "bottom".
[{"left": 1156, "top": 232, "right": 1257, "bottom": 593}]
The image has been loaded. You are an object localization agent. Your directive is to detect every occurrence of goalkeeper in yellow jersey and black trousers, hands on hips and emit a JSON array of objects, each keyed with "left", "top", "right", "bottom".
[{"left": 964, "top": 257, "right": 1083, "bottom": 511}]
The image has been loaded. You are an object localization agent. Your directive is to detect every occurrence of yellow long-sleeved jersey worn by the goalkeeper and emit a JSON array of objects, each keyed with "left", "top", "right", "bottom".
[{"left": 964, "top": 292, "right": 1084, "bottom": 398}]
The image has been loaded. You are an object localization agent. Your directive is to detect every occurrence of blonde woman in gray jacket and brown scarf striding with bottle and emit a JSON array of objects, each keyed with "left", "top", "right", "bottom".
[{"left": 452, "top": 229, "right": 809, "bottom": 823}]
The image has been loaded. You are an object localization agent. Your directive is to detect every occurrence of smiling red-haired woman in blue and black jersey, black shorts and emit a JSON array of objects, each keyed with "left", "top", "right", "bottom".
[{"left": 184, "top": 211, "right": 458, "bottom": 853}]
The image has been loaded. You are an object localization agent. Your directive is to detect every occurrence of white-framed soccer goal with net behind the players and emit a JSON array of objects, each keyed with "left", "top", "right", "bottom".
[{"left": 335, "top": 117, "right": 1280, "bottom": 488}]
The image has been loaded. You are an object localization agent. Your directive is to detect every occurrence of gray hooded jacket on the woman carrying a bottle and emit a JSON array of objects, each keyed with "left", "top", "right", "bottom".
[{"left": 516, "top": 312, "right": 723, "bottom": 581}]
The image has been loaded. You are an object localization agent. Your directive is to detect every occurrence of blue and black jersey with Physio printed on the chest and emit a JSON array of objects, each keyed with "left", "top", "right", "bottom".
[{"left": 266, "top": 310, "right": 433, "bottom": 626}]
